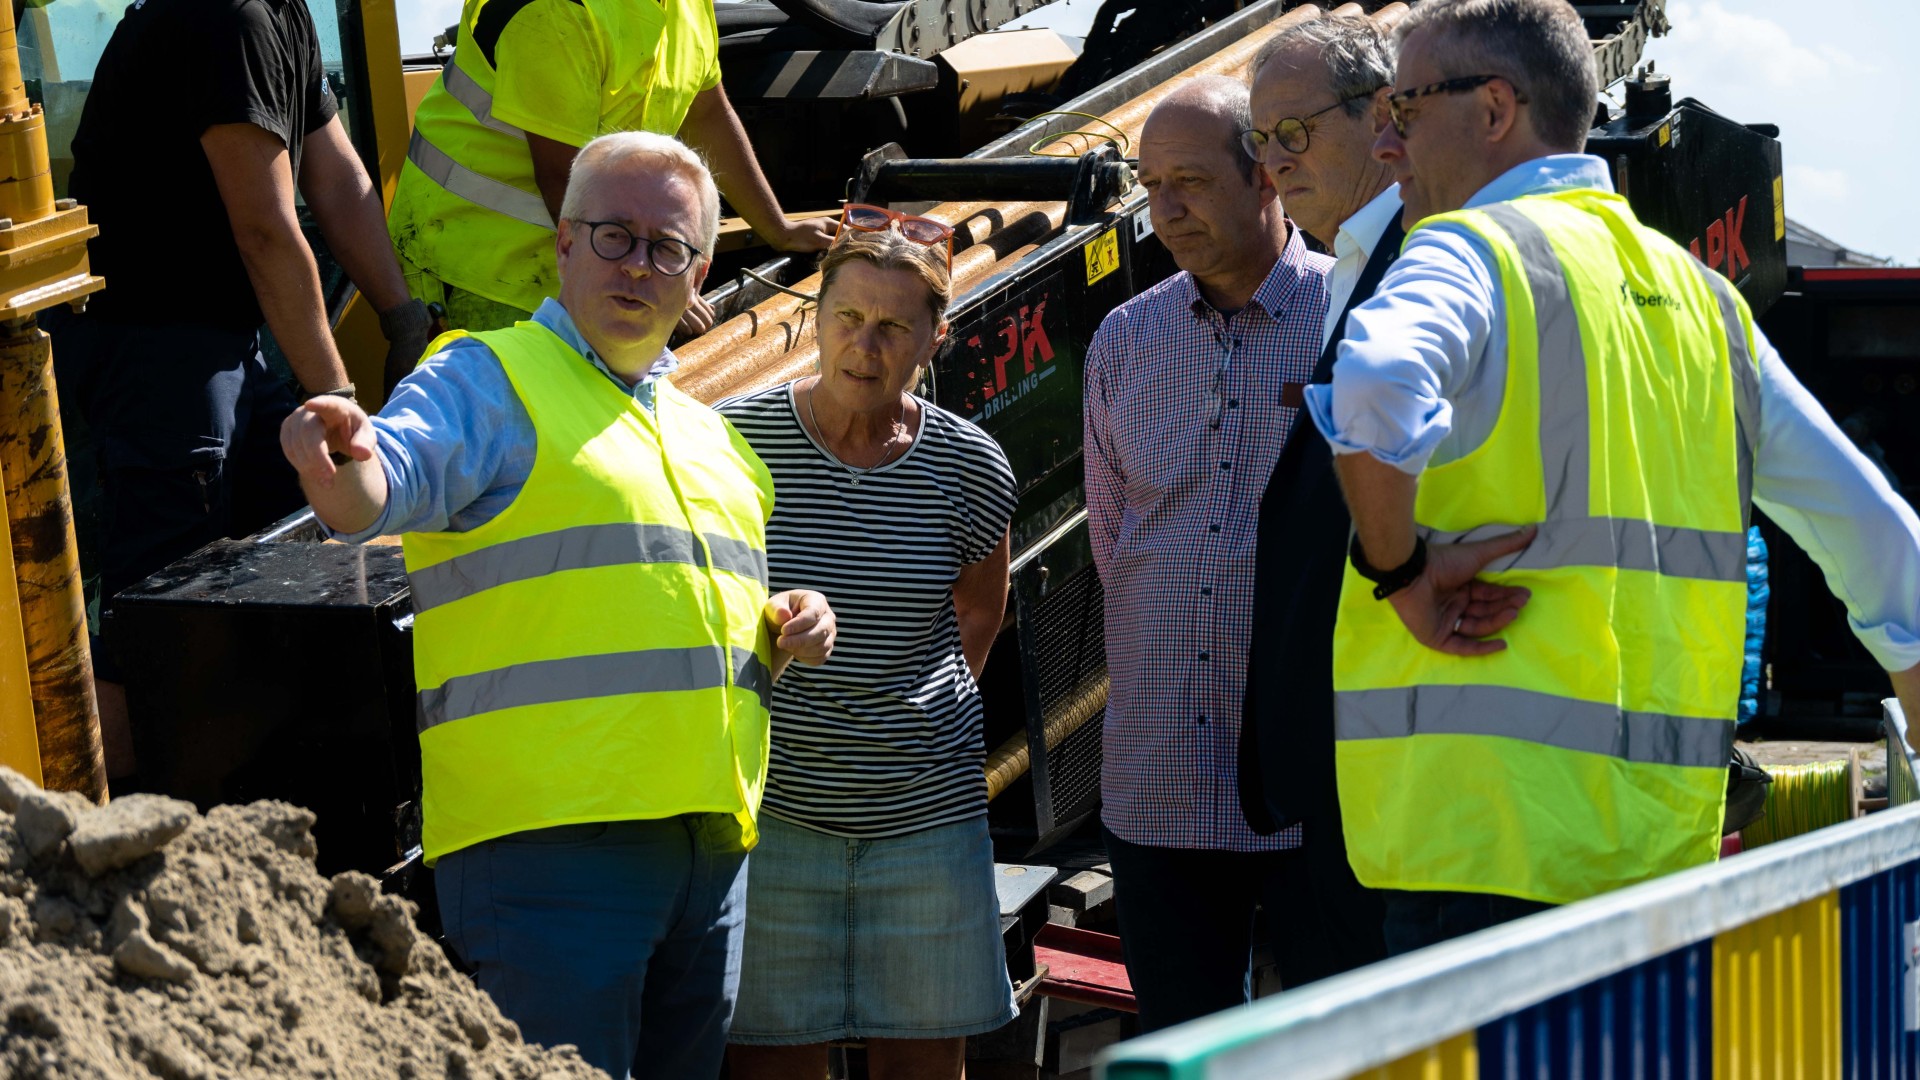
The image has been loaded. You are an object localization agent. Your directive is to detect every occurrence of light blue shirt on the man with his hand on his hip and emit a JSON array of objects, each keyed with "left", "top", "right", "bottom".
[{"left": 1306, "top": 154, "right": 1920, "bottom": 671}]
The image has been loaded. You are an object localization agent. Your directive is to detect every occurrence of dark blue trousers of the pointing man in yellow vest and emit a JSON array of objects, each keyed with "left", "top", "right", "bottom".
[{"left": 434, "top": 813, "right": 747, "bottom": 1080}]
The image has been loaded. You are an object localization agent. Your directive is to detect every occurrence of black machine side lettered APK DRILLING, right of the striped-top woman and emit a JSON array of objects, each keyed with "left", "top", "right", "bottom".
[{"left": 929, "top": 192, "right": 1175, "bottom": 857}]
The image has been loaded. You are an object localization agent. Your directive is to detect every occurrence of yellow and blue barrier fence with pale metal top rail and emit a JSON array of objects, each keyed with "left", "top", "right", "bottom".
[{"left": 1100, "top": 701, "right": 1920, "bottom": 1080}]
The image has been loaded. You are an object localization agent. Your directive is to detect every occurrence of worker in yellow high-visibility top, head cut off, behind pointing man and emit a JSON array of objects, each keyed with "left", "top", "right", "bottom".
[{"left": 388, "top": 0, "right": 833, "bottom": 365}]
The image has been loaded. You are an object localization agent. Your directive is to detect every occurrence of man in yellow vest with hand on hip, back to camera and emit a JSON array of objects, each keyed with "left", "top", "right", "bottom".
[{"left": 1308, "top": 0, "right": 1920, "bottom": 953}]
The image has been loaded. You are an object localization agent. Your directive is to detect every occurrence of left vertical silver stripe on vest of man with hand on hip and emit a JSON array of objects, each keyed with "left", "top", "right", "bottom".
[{"left": 1480, "top": 202, "right": 1592, "bottom": 521}]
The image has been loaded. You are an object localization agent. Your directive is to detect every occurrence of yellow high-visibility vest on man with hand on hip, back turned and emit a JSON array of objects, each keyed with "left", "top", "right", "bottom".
[{"left": 1334, "top": 190, "right": 1759, "bottom": 903}]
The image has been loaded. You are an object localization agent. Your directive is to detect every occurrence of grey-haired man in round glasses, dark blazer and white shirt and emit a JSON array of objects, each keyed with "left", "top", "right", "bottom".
[{"left": 1240, "top": 15, "right": 1400, "bottom": 974}]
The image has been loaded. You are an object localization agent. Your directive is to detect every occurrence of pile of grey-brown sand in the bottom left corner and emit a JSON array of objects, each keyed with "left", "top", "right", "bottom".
[{"left": 0, "top": 769, "right": 605, "bottom": 1080}]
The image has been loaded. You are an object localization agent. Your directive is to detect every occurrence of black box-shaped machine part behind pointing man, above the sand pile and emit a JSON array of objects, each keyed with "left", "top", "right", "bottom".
[{"left": 113, "top": 540, "right": 420, "bottom": 872}]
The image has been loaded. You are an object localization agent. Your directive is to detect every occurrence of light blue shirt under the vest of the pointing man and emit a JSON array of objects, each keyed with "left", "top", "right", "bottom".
[{"left": 330, "top": 298, "right": 678, "bottom": 544}]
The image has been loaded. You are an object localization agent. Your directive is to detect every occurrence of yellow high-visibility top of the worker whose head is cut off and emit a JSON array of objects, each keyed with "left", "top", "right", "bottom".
[{"left": 388, "top": 0, "right": 720, "bottom": 311}]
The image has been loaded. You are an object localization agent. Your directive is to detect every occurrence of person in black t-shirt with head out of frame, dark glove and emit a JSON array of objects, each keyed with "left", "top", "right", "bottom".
[{"left": 42, "top": 0, "right": 430, "bottom": 776}]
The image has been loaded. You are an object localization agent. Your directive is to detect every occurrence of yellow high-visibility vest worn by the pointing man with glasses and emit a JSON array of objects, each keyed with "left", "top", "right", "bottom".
[{"left": 403, "top": 323, "right": 774, "bottom": 865}]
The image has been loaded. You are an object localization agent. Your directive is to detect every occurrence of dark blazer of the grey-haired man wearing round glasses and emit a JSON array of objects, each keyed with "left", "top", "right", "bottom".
[{"left": 1240, "top": 215, "right": 1405, "bottom": 844}]
